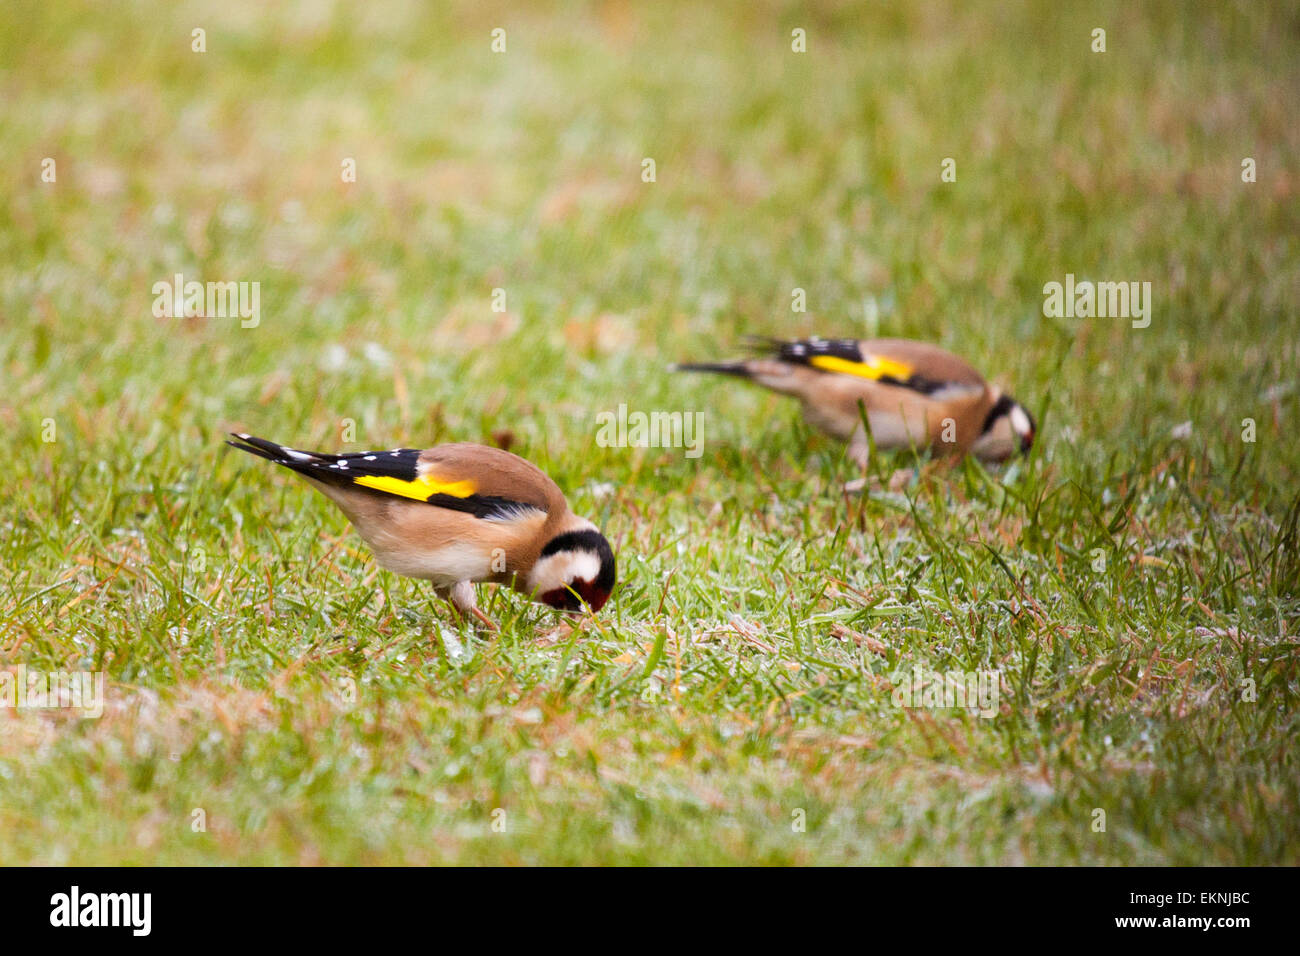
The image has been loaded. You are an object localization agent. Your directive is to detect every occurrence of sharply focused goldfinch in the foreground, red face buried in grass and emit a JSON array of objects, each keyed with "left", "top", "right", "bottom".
[{"left": 226, "top": 433, "right": 615, "bottom": 626}]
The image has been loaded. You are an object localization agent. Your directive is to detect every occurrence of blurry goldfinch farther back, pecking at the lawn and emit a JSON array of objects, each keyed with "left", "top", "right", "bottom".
[{"left": 673, "top": 338, "right": 1035, "bottom": 467}]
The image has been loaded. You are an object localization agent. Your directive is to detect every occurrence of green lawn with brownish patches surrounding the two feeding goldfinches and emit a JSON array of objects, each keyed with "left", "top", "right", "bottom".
[{"left": 0, "top": 0, "right": 1300, "bottom": 864}]
